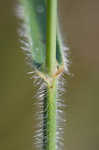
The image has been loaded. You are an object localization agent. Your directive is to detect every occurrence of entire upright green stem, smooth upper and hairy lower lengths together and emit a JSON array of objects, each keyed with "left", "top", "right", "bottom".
[{"left": 44, "top": 0, "right": 57, "bottom": 150}]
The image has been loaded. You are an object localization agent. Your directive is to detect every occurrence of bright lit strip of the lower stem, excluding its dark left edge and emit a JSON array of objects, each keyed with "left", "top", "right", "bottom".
[{"left": 47, "top": 80, "right": 56, "bottom": 150}]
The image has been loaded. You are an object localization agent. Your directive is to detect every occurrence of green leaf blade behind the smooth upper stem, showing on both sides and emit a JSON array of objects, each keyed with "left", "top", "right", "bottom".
[{"left": 20, "top": 0, "right": 63, "bottom": 72}]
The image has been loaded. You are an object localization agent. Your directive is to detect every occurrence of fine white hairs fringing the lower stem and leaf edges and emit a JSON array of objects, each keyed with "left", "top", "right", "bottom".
[{"left": 16, "top": 2, "right": 69, "bottom": 150}]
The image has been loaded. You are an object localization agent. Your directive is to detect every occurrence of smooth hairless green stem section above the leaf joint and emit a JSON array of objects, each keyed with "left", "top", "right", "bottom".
[{"left": 46, "top": 0, "right": 57, "bottom": 75}]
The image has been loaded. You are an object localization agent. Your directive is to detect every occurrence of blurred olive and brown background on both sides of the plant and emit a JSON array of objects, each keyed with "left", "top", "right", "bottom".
[{"left": 0, "top": 0, "right": 99, "bottom": 150}]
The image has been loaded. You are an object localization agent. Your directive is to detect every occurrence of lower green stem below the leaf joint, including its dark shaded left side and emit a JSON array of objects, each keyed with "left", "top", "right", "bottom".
[{"left": 43, "top": 79, "right": 57, "bottom": 150}]
